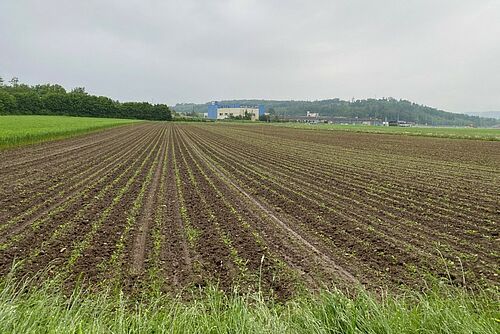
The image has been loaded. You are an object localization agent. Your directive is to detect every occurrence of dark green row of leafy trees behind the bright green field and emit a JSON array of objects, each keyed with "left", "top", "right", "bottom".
[{"left": 0, "top": 77, "right": 172, "bottom": 121}]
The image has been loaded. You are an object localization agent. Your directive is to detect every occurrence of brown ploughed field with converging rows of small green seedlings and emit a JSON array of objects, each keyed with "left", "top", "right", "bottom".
[{"left": 0, "top": 123, "right": 500, "bottom": 299}]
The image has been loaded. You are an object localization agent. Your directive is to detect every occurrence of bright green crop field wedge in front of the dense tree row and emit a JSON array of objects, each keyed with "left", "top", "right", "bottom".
[{"left": 0, "top": 116, "right": 138, "bottom": 149}]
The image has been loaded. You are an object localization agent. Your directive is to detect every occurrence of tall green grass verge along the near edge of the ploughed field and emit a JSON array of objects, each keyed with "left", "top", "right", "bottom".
[{"left": 0, "top": 277, "right": 500, "bottom": 333}]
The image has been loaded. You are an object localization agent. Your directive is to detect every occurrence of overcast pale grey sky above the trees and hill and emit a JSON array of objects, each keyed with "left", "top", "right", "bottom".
[{"left": 0, "top": 0, "right": 500, "bottom": 112}]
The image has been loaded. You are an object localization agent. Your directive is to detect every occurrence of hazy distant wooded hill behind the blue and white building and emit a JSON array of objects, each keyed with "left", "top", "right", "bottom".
[{"left": 173, "top": 98, "right": 500, "bottom": 127}]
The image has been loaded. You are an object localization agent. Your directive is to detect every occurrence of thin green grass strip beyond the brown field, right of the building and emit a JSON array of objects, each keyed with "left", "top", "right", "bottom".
[{"left": 271, "top": 123, "right": 500, "bottom": 141}]
